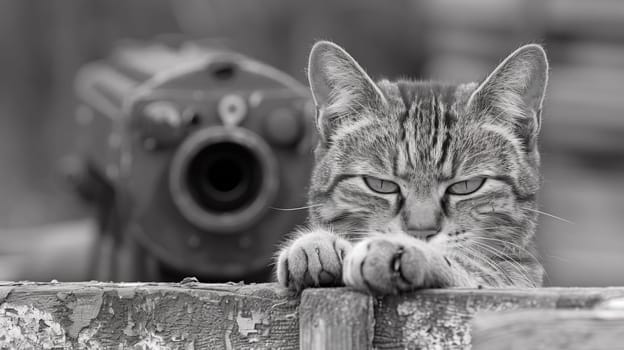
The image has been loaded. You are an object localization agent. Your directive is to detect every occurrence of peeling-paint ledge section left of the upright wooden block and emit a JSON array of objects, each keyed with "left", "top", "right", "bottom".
[{"left": 0, "top": 282, "right": 299, "bottom": 349}]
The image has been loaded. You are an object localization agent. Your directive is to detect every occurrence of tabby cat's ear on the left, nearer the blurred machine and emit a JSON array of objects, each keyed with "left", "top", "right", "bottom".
[{"left": 308, "top": 41, "right": 387, "bottom": 141}]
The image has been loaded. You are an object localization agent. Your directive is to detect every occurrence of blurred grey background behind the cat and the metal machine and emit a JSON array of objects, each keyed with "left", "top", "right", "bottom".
[{"left": 0, "top": 0, "right": 624, "bottom": 286}]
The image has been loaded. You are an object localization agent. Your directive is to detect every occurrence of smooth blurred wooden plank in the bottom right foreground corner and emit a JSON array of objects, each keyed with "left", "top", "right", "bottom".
[{"left": 472, "top": 309, "right": 624, "bottom": 350}]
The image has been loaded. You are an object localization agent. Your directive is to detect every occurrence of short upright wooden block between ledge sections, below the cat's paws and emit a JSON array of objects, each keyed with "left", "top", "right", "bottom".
[{"left": 299, "top": 288, "right": 375, "bottom": 350}]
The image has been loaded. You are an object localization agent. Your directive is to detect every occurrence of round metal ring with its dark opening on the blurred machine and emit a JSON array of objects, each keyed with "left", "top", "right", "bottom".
[{"left": 169, "top": 126, "right": 279, "bottom": 234}]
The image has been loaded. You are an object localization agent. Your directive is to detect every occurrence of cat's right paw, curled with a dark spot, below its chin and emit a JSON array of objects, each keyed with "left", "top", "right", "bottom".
[{"left": 343, "top": 236, "right": 427, "bottom": 295}]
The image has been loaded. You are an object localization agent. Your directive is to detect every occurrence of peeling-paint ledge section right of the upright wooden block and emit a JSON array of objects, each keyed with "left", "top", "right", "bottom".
[{"left": 374, "top": 288, "right": 624, "bottom": 349}]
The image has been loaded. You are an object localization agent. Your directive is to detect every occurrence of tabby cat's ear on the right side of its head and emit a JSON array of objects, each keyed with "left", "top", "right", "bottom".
[{"left": 468, "top": 44, "right": 548, "bottom": 151}]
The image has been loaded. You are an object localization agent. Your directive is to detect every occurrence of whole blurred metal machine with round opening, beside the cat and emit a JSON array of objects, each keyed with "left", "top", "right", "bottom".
[{"left": 73, "top": 42, "right": 315, "bottom": 281}]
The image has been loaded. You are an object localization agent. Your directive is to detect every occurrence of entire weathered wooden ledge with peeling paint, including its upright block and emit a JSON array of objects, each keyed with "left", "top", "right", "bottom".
[{"left": 0, "top": 281, "right": 624, "bottom": 349}]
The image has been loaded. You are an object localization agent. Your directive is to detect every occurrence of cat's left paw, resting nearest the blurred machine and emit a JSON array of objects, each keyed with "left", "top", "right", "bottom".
[{"left": 277, "top": 230, "right": 351, "bottom": 292}]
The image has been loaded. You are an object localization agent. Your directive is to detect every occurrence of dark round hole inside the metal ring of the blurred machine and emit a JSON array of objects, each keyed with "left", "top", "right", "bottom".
[{"left": 186, "top": 142, "right": 263, "bottom": 212}]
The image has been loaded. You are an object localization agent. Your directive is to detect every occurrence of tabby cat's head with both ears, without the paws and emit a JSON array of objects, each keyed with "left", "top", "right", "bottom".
[{"left": 308, "top": 42, "right": 548, "bottom": 284}]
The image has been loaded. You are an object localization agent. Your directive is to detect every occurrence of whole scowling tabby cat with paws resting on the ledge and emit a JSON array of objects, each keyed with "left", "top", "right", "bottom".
[{"left": 276, "top": 41, "right": 548, "bottom": 295}]
